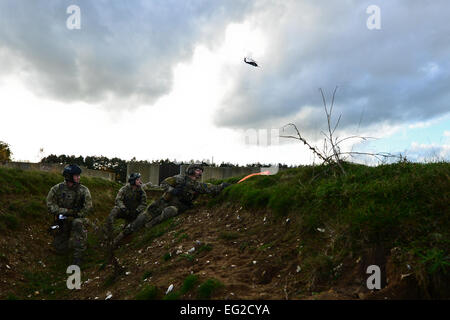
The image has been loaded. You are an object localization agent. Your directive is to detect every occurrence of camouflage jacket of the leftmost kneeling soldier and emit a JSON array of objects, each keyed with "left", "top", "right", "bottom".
[{"left": 47, "top": 182, "right": 92, "bottom": 218}]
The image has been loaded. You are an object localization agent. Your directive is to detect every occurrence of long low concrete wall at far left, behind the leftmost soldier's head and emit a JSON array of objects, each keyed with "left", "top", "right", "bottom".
[{"left": 0, "top": 162, "right": 116, "bottom": 181}]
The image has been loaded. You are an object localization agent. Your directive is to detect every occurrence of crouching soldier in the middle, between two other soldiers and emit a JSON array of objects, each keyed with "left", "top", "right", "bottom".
[{"left": 106, "top": 173, "right": 147, "bottom": 239}]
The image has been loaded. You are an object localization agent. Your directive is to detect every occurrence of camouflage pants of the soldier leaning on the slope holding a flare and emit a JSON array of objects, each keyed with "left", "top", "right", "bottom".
[{"left": 124, "top": 200, "right": 184, "bottom": 235}]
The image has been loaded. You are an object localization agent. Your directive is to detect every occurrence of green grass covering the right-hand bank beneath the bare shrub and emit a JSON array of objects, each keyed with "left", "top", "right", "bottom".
[{"left": 209, "top": 162, "right": 450, "bottom": 296}]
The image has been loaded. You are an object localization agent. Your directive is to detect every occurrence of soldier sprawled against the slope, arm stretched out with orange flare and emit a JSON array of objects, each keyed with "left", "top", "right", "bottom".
[{"left": 108, "top": 164, "right": 229, "bottom": 250}]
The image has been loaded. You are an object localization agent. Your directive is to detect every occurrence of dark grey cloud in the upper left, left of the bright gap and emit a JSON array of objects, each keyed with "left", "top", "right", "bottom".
[{"left": 0, "top": 0, "right": 250, "bottom": 107}]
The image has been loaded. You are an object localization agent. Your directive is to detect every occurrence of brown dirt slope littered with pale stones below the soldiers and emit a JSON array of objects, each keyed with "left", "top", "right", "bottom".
[{"left": 0, "top": 199, "right": 420, "bottom": 299}]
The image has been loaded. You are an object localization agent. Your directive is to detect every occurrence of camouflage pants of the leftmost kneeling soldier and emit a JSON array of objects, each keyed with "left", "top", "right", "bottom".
[{"left": 53, "top": 218, "right": 87, "bottom": 258}]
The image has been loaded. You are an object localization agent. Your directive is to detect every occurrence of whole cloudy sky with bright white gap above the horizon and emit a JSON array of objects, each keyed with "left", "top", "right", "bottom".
[{"left": 0, "top": 0, "right": 450, "bottom": 164}]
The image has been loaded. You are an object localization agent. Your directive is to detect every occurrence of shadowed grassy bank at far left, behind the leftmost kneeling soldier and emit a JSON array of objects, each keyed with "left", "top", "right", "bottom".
[{"left": 0, "top": 168, "right": 120, "bottom": 299}]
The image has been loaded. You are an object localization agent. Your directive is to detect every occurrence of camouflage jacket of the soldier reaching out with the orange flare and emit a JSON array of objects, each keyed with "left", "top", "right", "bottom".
[{"left": 161, "top": 174, "right": 223, "bottom": 205}]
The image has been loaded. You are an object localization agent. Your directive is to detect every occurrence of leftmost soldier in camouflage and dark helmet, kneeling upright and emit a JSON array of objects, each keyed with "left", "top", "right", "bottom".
[{"left": 47, "top": 165, "right": 92, "bottom": 266}]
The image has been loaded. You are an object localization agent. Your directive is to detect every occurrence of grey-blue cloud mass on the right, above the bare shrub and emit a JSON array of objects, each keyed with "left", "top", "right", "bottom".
[{"left": 215, "top": 1, "right": 450, "bottom": 136}]
